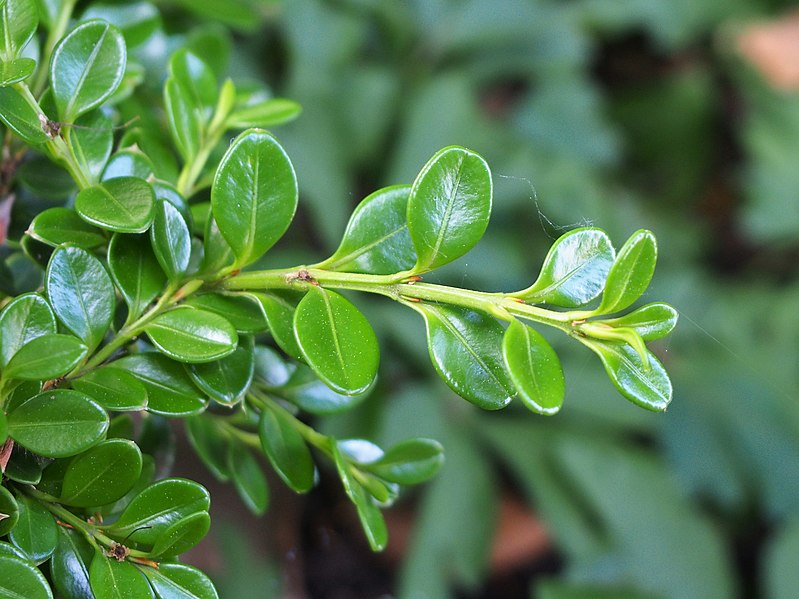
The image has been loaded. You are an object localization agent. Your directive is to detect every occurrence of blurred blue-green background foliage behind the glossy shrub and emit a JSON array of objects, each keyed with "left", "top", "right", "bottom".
[{"left": 81, "top": 0, "right": 799, "bottom": 599}]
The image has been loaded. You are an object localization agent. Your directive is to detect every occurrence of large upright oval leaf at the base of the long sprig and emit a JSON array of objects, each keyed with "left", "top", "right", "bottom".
[{"left": 211, "top": 129, "right": 297, "bottom": 267}]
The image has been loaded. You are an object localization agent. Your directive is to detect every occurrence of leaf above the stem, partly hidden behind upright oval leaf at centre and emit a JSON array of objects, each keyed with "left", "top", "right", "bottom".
[{"left": 319, "top": 185, "right": 416, "bottom": 275}]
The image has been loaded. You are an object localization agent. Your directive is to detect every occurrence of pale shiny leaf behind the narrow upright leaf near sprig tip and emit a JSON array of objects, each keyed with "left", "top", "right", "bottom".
[{"left": 516, "top": 228, "right": 615, "bottom": 308}]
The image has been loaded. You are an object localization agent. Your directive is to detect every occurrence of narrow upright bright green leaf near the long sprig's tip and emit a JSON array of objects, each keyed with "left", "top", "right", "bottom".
[{"left": 594, "top": 230, "right": 657, "bottom": 314}]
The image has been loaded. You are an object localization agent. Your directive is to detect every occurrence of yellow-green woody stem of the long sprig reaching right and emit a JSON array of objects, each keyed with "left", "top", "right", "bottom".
[{"left": 219, "top": 268, "right": 575, "bottom": 334}]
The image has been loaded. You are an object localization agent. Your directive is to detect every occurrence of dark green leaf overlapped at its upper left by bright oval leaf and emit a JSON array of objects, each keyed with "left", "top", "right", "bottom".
[{"left": 186, "top": 337, "right": 255, "bottom": 405}]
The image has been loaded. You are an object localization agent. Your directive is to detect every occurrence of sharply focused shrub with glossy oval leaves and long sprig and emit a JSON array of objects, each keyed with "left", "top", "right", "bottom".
[{"left": 0, "top": 0, "right": 676, "bottom": 599}]
